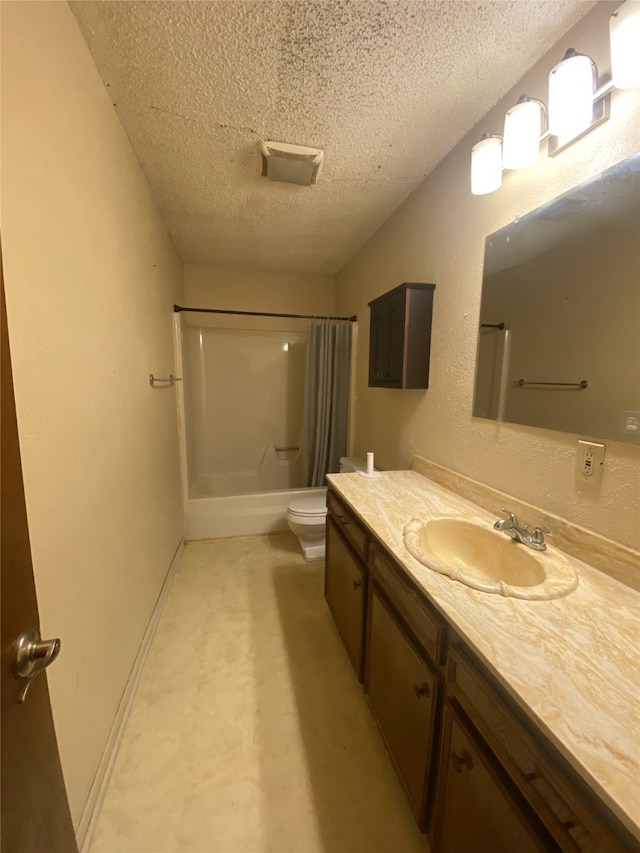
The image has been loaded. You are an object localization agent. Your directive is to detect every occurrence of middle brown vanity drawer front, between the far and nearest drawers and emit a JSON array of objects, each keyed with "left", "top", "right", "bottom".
[{"left": 369, "top": 542, "right": 445, "bottom": 665}]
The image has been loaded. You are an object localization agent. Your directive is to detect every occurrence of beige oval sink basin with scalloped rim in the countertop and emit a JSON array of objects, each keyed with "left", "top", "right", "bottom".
[{"left": 404, "top": 518, "right": 578, "bottom": 600}]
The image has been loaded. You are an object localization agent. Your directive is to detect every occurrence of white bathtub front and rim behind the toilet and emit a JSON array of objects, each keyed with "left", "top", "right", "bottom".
[{"left": 185, "top": 488, "right": 326, "bottom": 539}]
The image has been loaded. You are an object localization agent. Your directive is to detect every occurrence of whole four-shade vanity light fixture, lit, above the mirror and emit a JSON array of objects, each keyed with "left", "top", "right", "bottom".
[{"left": 471, "top": 0, "right": 640, "bottom": 195}]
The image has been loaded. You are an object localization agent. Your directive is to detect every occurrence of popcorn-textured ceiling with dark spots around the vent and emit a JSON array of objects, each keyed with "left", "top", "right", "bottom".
[{"left": 70, "top": 0, "right": 593, "bottom": 273}]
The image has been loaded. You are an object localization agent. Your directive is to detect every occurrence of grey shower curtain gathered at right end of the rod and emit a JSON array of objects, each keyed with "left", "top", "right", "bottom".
[{"left": 303, "top": 323, "right": 351, "bottom": 486}]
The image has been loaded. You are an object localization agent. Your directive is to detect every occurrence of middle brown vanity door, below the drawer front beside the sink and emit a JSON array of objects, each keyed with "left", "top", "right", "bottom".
[{"left": 365, "top": 585, "right": 438, "bottom": 826}]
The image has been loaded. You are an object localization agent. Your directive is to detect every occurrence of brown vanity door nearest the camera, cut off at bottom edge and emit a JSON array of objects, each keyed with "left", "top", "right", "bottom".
[{"left": 433, "top": 707, "right": 555, "bottom": 853}]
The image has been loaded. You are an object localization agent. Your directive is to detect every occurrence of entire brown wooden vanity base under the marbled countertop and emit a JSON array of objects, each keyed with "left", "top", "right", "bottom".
[{"left": 325, "top": 489, "right": 640, "bottom": 853}]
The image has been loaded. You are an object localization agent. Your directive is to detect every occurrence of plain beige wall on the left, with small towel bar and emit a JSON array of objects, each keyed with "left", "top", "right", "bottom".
[{"left": 2, "top": 2, "right": 182, "bottom": 825}]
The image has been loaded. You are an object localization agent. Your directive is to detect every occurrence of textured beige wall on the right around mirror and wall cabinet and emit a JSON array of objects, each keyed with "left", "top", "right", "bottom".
[{"left": 337, "top": 3, "right": 640, "bottom": 547}]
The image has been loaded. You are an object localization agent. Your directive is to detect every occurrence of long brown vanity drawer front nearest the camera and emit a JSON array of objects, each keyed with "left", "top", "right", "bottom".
[{"left": 446, "top": 645, "right": 638, "bottom": 853}]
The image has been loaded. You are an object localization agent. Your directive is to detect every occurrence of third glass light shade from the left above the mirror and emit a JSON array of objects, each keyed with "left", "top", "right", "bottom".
[{"left": 549, "top": 50, "right": 595, "bottom": 139}]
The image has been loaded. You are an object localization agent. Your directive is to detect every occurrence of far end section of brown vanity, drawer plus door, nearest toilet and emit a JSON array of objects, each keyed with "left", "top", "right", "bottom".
[{"left": 324, "top": 492, "right": 368, "bottom": 681}]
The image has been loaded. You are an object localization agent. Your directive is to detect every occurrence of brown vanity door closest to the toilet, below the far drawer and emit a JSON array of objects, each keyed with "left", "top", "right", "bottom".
[{"left": 324, "top": 516, "right": 366, "bottom": 681}]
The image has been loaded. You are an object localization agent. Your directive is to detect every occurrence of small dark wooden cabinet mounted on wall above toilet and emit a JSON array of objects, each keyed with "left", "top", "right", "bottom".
[{"left": 369, "top": 282, "right": 435, "bottom": 388}]
